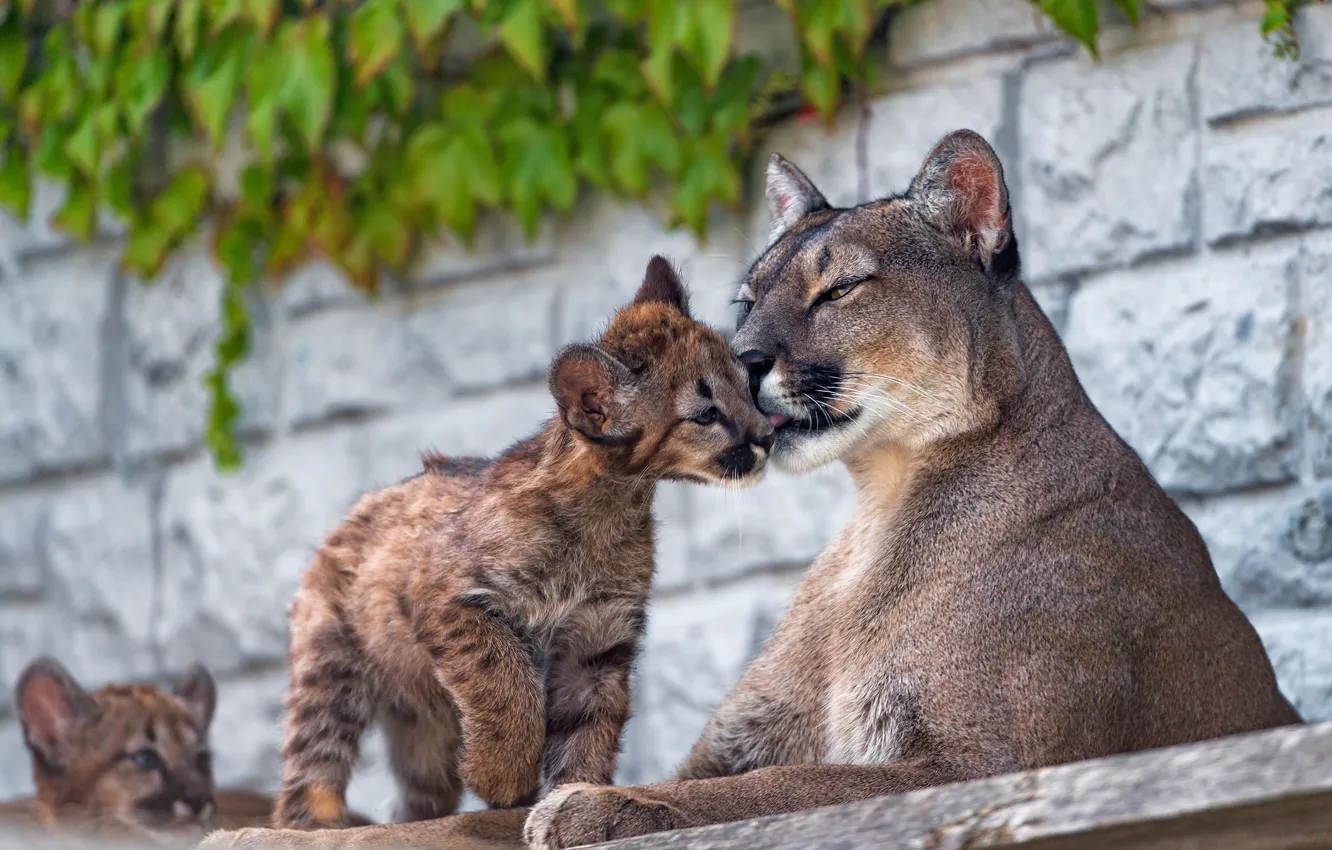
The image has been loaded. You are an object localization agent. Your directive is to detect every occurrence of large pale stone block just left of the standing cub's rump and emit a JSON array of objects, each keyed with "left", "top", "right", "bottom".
[{"left": 155, "top": 428, "right": 361, "bottom": 674}]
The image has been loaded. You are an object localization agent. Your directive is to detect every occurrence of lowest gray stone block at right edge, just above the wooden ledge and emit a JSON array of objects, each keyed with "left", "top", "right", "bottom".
[{"left": 1253, "top": 612, "right": 1332, "bottom": 722}]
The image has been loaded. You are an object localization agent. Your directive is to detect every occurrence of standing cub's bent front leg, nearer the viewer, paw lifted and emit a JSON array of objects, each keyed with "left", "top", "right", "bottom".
[{"left": 431, "top": 597, "right": 546, "bottom": 807}]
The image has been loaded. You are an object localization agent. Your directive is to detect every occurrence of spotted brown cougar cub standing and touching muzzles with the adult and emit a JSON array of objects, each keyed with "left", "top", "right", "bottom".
[{"left": 276, "top": 257, "right": 773, "bottom": 827}]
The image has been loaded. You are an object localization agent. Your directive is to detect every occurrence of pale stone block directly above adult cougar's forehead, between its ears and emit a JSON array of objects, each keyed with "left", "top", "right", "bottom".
[{"left": 868, "top": 73, "right": 1001, "bottom": 197}]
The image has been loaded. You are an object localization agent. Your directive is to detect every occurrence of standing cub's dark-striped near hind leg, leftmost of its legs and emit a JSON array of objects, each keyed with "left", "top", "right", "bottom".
[{"left": 273, "top": 596, "right": 376, "bottom": 829}]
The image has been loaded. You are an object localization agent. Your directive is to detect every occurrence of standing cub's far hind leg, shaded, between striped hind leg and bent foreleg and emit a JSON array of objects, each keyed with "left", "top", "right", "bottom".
[{"left": 382, "top": 705, "right": 462, "bottom": 822}]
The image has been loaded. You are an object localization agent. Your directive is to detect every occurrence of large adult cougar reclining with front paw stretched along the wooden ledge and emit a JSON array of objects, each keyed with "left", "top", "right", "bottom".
[{"left": 516, "top": 132, "right": 1300, "bottom": 850}]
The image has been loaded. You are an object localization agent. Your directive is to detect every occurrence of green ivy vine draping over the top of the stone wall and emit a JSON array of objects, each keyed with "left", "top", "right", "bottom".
[{"left": 0, "top": 0, "right": 1303, "bottom": 469}]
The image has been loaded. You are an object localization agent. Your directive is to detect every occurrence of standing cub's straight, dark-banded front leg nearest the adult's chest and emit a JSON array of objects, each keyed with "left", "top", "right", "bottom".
[{"left": 538, "top": 636, "right": 638, "bottom": 797}]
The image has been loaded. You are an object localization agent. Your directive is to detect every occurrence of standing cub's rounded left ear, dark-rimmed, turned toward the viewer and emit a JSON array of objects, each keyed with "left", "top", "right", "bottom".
[{"left": 547, "top": 345, "right": 629, "bottom": 442}]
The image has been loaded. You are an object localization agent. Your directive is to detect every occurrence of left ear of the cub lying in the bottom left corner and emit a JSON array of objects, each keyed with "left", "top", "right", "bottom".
[{"left": 15, "top": 658, "right": 93, "bottom": 773}]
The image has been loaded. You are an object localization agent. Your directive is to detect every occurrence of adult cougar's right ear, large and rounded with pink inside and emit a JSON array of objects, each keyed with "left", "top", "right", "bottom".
[{"left": 907, "top": 129, "right": 1016, "bottom": 276}]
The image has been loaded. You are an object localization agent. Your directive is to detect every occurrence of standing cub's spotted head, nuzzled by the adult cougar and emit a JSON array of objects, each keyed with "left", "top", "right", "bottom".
[{"left": 549, "top": 257, "right": 773, "bottom": 486}]
